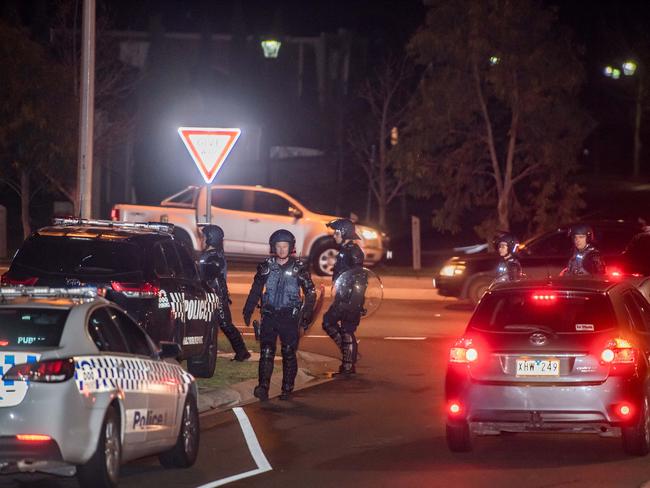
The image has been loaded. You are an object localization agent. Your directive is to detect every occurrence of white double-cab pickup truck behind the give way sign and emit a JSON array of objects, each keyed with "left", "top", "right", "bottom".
[{"left": 111, "top": 185, "right": 384, "bottom": 275}]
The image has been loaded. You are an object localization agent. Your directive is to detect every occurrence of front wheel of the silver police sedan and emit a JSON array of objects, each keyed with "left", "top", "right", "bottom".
[{"left": 158, "top": 394, "right": 201, "bottom": 468}]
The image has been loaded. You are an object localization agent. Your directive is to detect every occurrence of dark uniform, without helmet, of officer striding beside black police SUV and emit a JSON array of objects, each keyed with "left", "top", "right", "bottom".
[{"left": 199, "top": 249, "right": 251, "bottom": 361}]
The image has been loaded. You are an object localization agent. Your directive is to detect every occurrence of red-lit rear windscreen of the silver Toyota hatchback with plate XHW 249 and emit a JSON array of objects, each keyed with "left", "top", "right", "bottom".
[{"left": 469, "top": 290, "right": 616, "bottom": 333}]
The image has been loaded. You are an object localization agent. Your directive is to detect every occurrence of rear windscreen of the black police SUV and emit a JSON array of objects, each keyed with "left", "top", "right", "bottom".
[{"left": 12, "top": 236, "right": 141, "bottom": 276}]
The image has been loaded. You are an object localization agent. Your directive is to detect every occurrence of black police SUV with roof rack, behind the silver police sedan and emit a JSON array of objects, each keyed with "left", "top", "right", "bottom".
[{"left": 2, "top": 219, "right": 220, "bottom": 377}]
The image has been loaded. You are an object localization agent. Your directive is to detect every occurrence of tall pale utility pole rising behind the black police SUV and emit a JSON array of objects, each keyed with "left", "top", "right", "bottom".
[{"left": 75, "top": 0, "right": 95, "bottom": 219}]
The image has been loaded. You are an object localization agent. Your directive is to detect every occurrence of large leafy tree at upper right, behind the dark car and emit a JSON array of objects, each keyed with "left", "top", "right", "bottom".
[{"left": 402, "top": 0, "right": 590, "bottom": 235}]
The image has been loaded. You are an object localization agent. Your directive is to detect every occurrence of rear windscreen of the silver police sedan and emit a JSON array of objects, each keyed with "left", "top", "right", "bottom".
[{"left": 0, "top": 308, "right": 69, "bottom": 350}]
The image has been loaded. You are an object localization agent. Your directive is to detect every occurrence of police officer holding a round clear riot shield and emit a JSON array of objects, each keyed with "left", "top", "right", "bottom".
[{"left": 323, "top": 219, "right": 365, "bottom": 375}]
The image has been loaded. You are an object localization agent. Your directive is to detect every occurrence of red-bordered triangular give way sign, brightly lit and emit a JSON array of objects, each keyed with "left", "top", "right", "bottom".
[{"left": 178, "top": 127, "right": 241, "bottom": 185}]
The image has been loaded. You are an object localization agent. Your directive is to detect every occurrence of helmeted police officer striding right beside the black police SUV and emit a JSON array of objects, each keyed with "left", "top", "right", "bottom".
[{"left": 199, "top": 225, "right": 251, "bottom": 361}]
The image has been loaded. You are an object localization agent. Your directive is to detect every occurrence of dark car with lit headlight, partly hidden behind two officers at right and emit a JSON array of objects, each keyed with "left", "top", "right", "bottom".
[{"left": 435, "top": 220, "right": 641, "bottom": 303}]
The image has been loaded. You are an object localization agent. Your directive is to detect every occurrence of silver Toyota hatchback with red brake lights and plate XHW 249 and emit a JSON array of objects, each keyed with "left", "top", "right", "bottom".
[{"left": 445, "top": 278, "right": 650, "bottom": 455}]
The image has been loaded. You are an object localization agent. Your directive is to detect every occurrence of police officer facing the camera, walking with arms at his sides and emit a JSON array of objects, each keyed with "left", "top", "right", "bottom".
[{"left": 244, "top": 229, "right": 316, "bottom": 401}]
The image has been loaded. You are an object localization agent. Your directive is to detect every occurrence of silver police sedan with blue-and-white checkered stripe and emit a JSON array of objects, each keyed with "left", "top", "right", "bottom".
[{"left": 0, "top": 287, "right": 199, "bottom": 487}]
